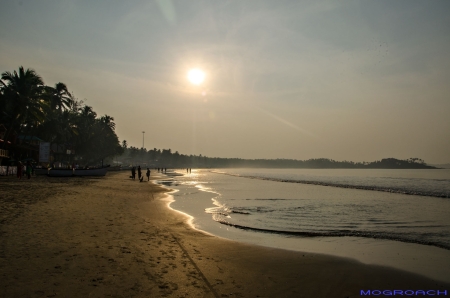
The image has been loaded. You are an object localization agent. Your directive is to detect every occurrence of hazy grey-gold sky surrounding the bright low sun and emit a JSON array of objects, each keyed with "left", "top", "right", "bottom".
[{"left": 0, "top": 0, "right": 450, "bottom": 164}]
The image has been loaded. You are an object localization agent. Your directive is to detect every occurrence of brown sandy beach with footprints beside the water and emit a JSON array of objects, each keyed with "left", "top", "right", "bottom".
[{"left": 0, "top": 172, "right": 450, "bottom": 298}]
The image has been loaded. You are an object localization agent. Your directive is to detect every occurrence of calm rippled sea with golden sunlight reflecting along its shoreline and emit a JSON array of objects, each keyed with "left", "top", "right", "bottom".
[{"left": 159, "top": 168, "right": 450, "bottom": 281}]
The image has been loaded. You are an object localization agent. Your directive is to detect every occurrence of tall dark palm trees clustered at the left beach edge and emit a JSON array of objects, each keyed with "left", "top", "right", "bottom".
[{"left": 0, "top": 66, "right": 123, "bottom": 164}]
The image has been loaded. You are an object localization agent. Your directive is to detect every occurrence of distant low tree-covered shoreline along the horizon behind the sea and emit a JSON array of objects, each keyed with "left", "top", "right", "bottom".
[{"left": 117, "top": 148, "right": 436, "bottom": 169}]
